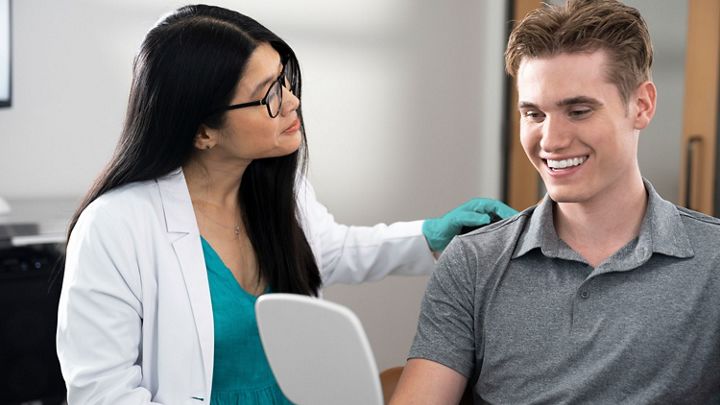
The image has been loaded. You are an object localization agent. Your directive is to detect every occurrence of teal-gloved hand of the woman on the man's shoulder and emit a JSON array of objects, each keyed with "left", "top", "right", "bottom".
[{"left": 422, "top": 198, "right": 517, "bottom": 252}]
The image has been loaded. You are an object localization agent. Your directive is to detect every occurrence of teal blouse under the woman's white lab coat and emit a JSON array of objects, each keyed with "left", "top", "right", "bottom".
[{"left": 201, "top": 238, "right": 292, "bottom": 405}]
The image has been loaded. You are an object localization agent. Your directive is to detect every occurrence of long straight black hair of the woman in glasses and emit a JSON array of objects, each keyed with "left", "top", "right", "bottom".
[{"left": 62, "top": 5, "right": 321, "bottom": 295}]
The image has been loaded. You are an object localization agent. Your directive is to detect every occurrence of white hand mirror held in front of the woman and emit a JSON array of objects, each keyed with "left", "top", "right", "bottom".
[{"left": 255, "top": 294, "right": 383, "bottom": 405}]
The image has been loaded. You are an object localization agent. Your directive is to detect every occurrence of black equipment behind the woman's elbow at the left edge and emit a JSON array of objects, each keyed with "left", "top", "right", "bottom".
[{"left": 0, "top": 241, "right": 65, "bottom": 405}]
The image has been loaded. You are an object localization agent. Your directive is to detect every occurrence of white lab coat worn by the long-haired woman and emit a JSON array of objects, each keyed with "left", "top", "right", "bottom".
[{"left": 57, "top": 170, "right": 434, "bottom": 405}]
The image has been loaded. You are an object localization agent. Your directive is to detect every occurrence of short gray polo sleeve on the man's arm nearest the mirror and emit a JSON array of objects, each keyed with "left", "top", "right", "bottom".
[{"left": 408, "top": 238, "right": 475, "bottom": 378}]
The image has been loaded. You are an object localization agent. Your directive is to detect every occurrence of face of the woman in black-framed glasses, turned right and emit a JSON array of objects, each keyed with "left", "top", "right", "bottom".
[{"left": 213, "top": 43, "right": 302, "bottom": 161}]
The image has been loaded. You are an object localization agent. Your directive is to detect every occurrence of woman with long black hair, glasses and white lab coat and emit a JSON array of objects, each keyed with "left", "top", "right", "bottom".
[{"left": 57, "top": 5, "right": 513, "bottom": 405}]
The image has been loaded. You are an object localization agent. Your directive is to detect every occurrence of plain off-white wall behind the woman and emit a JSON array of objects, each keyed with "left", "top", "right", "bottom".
[{"left": 0, "top": 0, "right": 505, "bottom": 369}]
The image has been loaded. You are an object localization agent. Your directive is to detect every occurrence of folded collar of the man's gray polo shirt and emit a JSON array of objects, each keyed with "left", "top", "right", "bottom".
[{"left": 513, "top": 179, "right": 694, "bottom": 268}]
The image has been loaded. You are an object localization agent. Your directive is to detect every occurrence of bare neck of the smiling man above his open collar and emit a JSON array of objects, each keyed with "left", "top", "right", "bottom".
[{"left": 553, "top": 177, "right": 647, "bottom": 267}]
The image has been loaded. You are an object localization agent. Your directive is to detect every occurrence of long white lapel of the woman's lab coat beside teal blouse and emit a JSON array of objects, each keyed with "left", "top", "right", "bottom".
[{"left": 158, "top": 169, "right": 215, "bottom": 388}]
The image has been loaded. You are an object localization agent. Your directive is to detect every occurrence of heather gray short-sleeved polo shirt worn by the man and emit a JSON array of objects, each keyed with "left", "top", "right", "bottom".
[{"left": 409, "top": 182, "right": 720, "bottom": 404}]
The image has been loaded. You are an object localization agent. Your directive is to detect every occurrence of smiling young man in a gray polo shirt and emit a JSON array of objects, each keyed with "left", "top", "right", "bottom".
[{"left": 391, "top": 0, "right": 720, "bottom": 405}]
